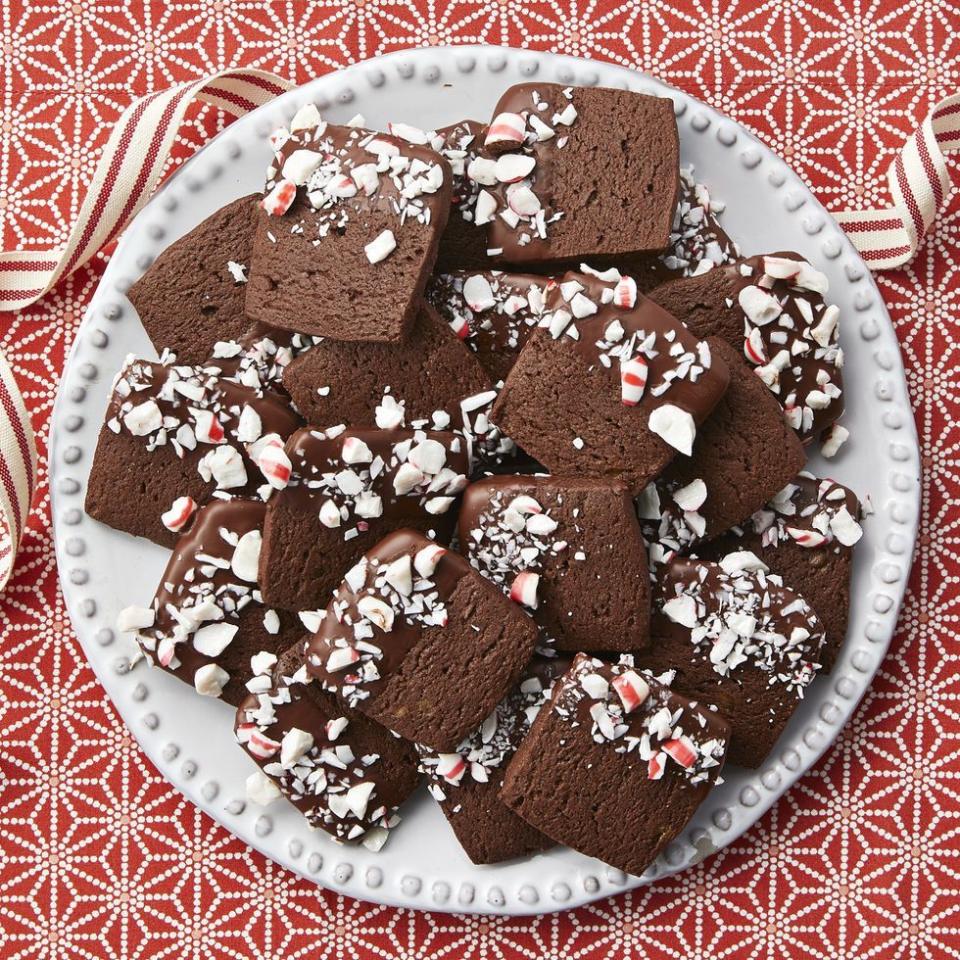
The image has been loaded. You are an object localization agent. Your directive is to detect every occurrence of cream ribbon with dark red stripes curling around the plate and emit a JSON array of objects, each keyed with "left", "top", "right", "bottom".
[{"left": 0, "top": 69, "right": 960, "bottom": 590}]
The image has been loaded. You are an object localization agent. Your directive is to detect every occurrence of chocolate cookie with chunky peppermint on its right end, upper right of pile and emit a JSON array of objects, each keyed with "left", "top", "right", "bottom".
[{"left": 650, "top": 253, "right": 843, "bottom": 442}]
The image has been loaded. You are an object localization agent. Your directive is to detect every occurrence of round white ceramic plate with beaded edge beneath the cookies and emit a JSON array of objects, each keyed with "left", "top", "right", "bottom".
[{"left": 50, "top": 47, "right": 919, "bottom": 914}]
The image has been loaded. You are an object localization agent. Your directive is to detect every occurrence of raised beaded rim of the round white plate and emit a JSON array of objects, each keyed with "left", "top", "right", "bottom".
[{"left": 49, "top": 46, "right": 920, "bottom": 915}]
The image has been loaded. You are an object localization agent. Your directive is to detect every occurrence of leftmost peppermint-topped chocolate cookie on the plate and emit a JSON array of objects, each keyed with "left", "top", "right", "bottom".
[{"left": 85, "top": 358, "right": 302, "bottom": 547}]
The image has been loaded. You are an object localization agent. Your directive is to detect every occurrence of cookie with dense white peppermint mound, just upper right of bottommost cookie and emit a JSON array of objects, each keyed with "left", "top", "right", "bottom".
[{"left": 637, "top": 552, "right": 824, "bottom": 767}]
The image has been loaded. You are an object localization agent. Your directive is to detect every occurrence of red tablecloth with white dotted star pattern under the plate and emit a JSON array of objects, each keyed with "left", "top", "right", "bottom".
[{"left": 0, "top": 0, "right": 960, "bottom": 960}]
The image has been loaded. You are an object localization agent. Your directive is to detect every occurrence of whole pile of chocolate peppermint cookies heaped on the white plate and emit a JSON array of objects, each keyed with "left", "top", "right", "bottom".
[{"left": 94, "top": 84, "right": 862, "bottom": 873}]
